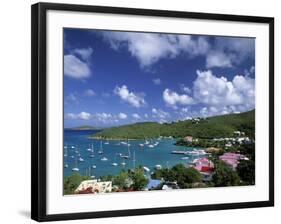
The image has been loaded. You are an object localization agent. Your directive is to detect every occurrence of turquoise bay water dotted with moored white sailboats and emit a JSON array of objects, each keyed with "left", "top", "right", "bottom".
[{"left": 63, "top": 130, "right": 203, "bottom": 178}]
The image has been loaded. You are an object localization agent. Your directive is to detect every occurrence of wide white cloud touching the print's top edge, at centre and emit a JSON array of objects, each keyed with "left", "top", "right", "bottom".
[{"left": 103, "top": 32, "right": 209, "bottom": 67}]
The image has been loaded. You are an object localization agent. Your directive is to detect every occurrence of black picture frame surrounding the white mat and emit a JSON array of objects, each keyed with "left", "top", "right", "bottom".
[{"left": 31, "top": 3, "right": 274, "bottom": 221}]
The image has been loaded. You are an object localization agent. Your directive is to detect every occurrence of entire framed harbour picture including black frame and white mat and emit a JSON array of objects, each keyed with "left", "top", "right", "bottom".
[{"left": 31, "top": 3, "right": 274, "bottom": 221}]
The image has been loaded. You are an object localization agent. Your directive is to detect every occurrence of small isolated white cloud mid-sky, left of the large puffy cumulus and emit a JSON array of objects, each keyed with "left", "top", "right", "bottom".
[{"left": 114, "top": 85, "right": 146, "bottom": 108}]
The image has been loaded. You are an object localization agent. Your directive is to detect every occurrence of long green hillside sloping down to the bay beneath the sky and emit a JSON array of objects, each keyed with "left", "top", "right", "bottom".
[{"left": 91, "top": 110, "right": 255, "bottom": 139}]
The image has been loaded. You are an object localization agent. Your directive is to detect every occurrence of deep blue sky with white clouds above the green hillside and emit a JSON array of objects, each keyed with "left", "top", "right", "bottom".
[{"left": 64, "top": 29, "right": 255, "bottom": 127}]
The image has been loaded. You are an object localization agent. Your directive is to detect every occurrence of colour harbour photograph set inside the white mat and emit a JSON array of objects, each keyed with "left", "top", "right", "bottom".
[{"left": 64, "top": 28, "right": 255, "bottom": 195}]
